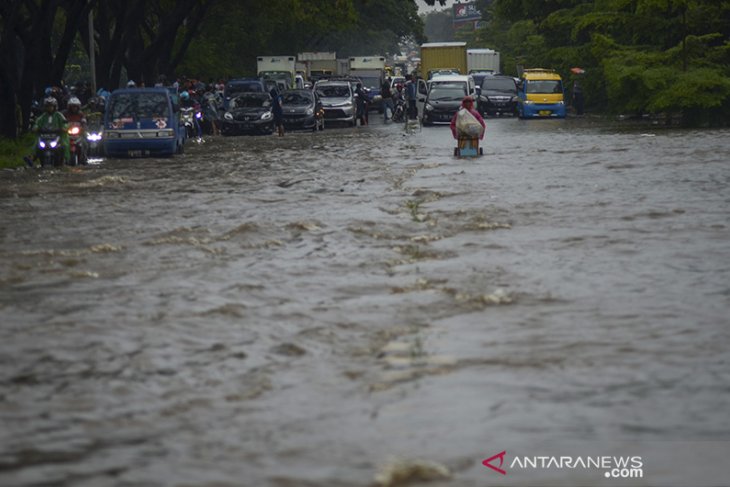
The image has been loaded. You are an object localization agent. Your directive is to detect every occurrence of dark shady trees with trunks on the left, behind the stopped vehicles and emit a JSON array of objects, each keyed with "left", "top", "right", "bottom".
[{"left": 0, "top": 0, "right": 445, "bottom": 137}]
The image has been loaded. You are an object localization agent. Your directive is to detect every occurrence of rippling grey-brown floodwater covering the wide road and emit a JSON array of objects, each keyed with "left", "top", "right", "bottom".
[{"left": 0, "top": 116, "right": 730, "bottom": 487}]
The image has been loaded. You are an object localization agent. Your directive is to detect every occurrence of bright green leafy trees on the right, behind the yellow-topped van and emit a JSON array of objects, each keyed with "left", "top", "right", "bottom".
[{"left": 470, "top": 0, "right": 730, "bottom": 123}]
